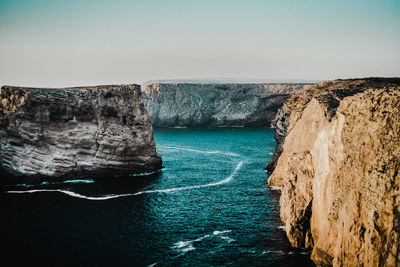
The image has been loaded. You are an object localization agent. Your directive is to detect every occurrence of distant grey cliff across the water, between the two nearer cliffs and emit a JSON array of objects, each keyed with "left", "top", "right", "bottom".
[{"left": 143, "top": 83, "right": 311, "bottom": 127}]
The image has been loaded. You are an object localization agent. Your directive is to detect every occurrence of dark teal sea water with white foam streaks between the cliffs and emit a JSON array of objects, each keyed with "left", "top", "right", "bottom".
[{"left": 1, "top": 128, "right": 313, "bottom": 266}]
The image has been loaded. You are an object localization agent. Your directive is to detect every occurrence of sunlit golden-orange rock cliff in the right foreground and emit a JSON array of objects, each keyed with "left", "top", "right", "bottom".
[{"left": 269, "top": 78, "right": 400, "bottom": 266}]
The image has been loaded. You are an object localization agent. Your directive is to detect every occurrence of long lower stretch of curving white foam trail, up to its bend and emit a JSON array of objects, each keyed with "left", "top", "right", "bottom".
[{"left": 6, "top": 161, "right": 244, "bottom": 200}]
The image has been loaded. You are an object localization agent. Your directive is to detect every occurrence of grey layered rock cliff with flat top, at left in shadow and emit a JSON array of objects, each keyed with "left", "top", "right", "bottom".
[{"left": 0, "top": 85, "right": 161, "bottom": 181}]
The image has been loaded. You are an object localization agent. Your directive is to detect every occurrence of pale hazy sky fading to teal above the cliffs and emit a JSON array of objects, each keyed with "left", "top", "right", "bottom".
[{"left": 0, "top": 0, "right": 400, "bottom": 87}]
